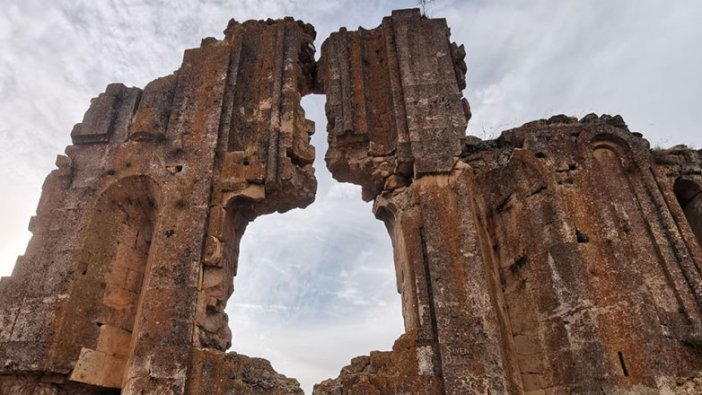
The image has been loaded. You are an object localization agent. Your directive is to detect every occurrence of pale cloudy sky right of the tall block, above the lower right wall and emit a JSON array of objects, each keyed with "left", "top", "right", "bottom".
[{"left": 442, "top": 0, "right": 702, "bottom": 147}]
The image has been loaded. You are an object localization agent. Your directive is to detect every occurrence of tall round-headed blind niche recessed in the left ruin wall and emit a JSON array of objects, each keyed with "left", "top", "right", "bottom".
[{"left": 61, "top": 176, "right": 159, "bottom": 388}]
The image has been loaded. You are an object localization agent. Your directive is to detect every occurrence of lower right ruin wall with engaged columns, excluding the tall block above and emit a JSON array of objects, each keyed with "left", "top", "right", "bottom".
[{"left": 316, "top": 110, "right": 702, "bottom": 395}]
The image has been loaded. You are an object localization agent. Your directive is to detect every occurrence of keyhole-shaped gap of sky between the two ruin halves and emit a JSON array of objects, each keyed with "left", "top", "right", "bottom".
[{"left": 226, "top": 96, "right": 404, "bottom": 394}]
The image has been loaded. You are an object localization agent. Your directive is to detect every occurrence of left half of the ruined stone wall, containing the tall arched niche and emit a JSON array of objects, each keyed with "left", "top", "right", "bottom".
[{"left": 0, "top": 15, "right": 316, "bottom": 394}]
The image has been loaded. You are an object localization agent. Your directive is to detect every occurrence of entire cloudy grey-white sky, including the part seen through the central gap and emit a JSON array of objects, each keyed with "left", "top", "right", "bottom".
[{"left": 0, "top": 0, "right": 702, "bottom": 393}]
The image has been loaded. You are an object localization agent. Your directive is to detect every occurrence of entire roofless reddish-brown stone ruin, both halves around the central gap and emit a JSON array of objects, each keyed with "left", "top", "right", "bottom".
[{"left": 0, "top": 6, "right": 702, "bottom": 395}]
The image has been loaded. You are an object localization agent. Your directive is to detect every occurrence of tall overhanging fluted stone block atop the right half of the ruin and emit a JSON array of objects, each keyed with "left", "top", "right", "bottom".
[{"left": 318, "top": 9, "right": 470, "bottom": 200}]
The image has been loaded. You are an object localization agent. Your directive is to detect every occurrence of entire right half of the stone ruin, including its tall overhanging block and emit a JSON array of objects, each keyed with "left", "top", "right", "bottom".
[{"left": 315, "top": 10, "right": 702, "bottom": 395}]
